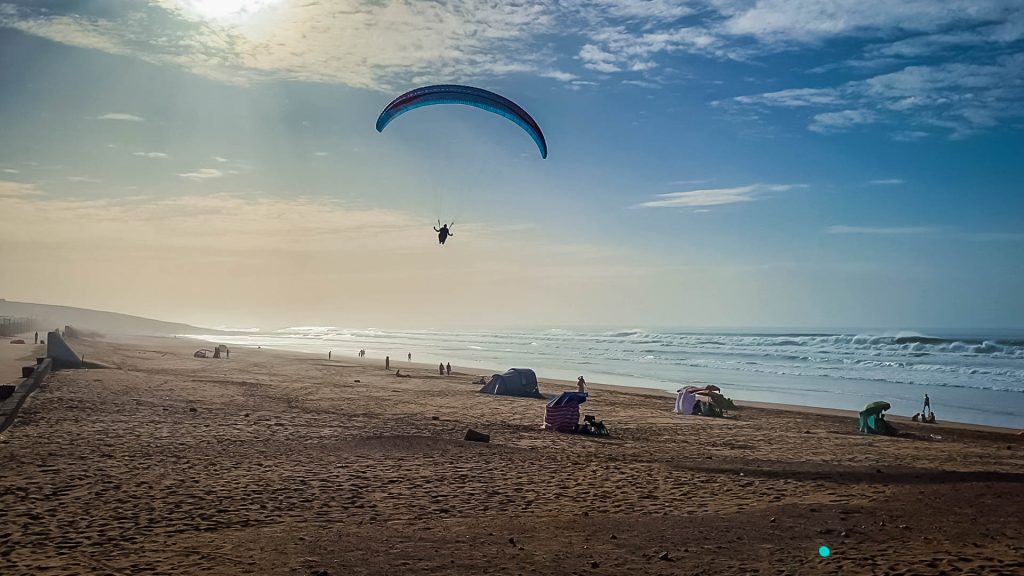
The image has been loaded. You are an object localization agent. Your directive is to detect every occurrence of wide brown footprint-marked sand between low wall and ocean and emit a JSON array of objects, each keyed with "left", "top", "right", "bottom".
[{"left": 0, "top": 338, "right": 1024, "bottom": 576}]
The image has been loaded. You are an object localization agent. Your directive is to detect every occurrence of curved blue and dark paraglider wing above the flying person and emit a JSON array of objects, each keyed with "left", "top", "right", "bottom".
[{"left": 377, "top": 84, "right": 548, "bottom": 158}]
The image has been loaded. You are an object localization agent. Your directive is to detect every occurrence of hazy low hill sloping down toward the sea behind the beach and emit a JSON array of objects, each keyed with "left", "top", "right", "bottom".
[{"left": 0, "top": 300, "right": 223, "bottom": 336}]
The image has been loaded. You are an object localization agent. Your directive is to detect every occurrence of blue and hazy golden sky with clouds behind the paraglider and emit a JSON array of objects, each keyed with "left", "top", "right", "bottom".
[{"left": 0, "top": 0, "right": 1024, "bottom": 330}]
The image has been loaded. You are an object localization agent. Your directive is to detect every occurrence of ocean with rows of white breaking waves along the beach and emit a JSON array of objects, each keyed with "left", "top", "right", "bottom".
[{"left": 182, "top": 326, "right": 1024, "bottom": 428}]
